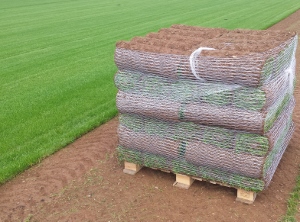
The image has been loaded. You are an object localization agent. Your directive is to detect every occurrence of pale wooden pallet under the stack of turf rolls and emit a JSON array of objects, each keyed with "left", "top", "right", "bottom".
[{"left": 123, "top": 162, "right": 256, "bottom": 204}]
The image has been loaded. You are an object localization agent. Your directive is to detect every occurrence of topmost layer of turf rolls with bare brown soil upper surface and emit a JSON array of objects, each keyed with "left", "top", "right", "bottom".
[{"left": 115, "top": 25, "right": 298, "bottom": 87}]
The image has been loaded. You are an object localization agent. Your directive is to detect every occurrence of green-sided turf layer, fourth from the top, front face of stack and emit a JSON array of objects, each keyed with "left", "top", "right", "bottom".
[{"left": 120, "top": 114, "right": 269, "bottom": 156}]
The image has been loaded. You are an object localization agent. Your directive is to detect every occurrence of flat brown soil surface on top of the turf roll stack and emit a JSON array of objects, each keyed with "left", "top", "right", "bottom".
[{"left": 117, "top": 25, "right": 295, "bottom": 57}]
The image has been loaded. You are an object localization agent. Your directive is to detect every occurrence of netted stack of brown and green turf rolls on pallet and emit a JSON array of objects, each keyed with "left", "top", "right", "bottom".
[{"left": 115, "top": 25, "right": 298, "bottom": 192}]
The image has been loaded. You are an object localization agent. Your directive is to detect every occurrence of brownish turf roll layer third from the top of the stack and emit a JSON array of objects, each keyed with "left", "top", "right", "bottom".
[{"left": 117, "top": 91, "right": 293, "bottom": 135}]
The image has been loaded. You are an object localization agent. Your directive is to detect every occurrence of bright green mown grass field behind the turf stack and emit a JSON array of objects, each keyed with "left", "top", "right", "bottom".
[{"left": 0, "top": 0, "right": 300, "bottom": 184}]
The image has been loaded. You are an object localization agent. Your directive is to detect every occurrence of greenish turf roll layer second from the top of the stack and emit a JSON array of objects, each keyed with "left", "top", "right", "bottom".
[{"left": 115, "top": 71, "right": 295, "bottom": 111}]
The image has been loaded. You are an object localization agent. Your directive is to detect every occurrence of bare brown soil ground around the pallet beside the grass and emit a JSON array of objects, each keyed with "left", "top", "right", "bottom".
[{"left": 0, "top": 10, "right": 300, "bottom": 221}]
